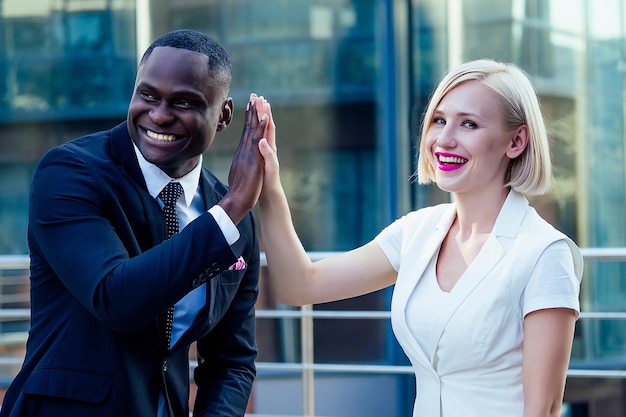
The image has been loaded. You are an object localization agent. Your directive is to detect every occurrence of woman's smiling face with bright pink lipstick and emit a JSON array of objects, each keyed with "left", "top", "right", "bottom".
[{"left": 426, "top": 81, "right": 525, "bottom": 194}]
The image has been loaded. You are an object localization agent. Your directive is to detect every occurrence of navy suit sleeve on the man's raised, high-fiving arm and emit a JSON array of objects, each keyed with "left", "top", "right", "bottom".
[{"left": 29, "top": 146, "right": 236, "bottom": 332}]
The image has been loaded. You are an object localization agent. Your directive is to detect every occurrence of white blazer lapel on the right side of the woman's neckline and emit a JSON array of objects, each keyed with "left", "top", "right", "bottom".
[{"left": 429, "top": 191, "right": 528, "bottom": 357}]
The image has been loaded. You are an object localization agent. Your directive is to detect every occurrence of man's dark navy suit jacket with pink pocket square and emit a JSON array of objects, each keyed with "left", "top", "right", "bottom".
[{"left": 0, "top": 123, "right": 259, "bottom": 417}]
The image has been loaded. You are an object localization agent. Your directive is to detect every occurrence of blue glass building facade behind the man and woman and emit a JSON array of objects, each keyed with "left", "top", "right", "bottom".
[{"left": 0, "top": 0, "right": 626, "bottom": 417}]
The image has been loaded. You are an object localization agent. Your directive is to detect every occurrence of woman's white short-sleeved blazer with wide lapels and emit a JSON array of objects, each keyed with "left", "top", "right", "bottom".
[{"left": 376, "top": 191, "right": 583, "bottom": 417}]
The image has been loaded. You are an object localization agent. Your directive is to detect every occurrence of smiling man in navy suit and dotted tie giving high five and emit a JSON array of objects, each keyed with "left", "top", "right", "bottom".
[{"left": 0, "top": 31, "right": 273, "bottom": 417}]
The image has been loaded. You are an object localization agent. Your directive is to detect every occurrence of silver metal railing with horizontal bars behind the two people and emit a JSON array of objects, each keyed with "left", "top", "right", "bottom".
[{"left": 0, "top": 248, "right": 626, "bottom": 416}]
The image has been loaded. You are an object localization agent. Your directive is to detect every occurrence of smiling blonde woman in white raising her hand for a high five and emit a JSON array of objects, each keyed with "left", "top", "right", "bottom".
[{"left": 254, "top": 60, "right": 583, "bottom": 417}]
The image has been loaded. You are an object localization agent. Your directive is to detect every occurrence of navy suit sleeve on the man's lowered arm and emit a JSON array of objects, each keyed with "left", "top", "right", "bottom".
[{"left": 194, "top": 215, "right": 260, "bottom": 417}]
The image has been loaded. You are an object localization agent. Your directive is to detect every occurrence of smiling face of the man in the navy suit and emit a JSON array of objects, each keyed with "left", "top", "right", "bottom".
[{"left": 128, "top": 47, "right": 232, "bottom": 178}]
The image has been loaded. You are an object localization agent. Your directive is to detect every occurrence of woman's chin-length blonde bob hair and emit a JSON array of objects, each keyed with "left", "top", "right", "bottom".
[{"left": 417, "top": 59, "right": 552, "bottom": 195}]
